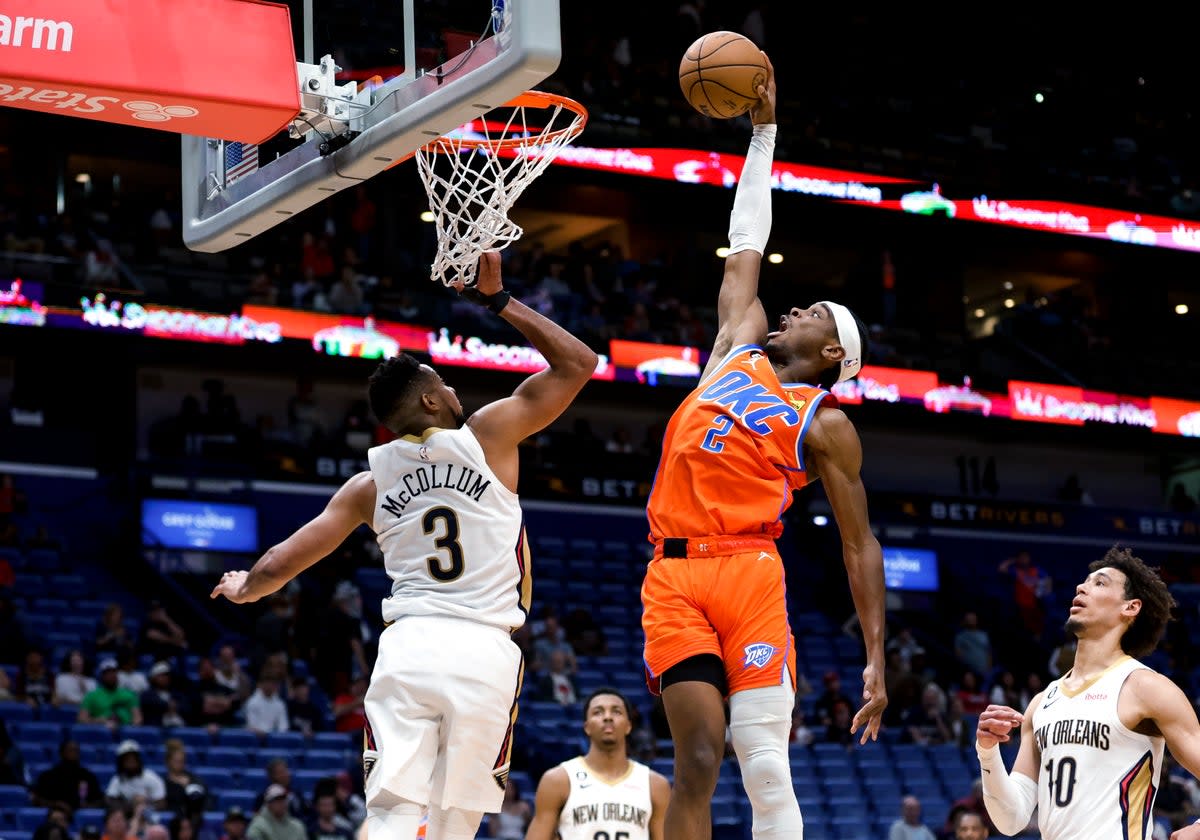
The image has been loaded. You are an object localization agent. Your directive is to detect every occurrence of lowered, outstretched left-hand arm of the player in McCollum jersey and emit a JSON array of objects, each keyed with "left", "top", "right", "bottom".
[{"left": 210, "top": 472, "right": 376, "bottom": 604}]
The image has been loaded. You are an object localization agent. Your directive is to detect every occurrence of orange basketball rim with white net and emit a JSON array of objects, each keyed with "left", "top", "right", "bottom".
[{"left": 416, "top": 90, "right": 588, "bottom": 286}]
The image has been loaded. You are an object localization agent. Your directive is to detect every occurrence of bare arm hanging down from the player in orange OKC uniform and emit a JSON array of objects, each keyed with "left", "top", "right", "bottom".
[{"left": 804, "top": 408, "right": 888, "bottom": 743}]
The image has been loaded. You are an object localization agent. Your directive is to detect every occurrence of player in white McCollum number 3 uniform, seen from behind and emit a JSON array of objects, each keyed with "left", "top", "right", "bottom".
[{"left": 212, "top": 252, "right": 598, "bottom": 840}]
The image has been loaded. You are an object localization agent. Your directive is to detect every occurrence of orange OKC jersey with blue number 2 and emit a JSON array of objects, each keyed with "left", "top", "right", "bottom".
[{"left": 647, "top": 344, "right": 838, "bottom": 541}]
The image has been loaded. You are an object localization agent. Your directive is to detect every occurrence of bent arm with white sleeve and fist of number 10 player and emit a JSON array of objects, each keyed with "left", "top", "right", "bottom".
[{"left": 976, "top": 694, "right": 1042, "bottom": 836}]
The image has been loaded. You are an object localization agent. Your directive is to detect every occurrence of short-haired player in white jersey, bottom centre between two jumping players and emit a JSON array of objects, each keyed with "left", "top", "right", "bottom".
[{"left": 526, "top": 688, "right": 671, "bottom": 840}]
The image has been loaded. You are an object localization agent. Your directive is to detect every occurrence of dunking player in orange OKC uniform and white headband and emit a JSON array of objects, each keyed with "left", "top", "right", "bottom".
[{"left": 642, "top": 55, "right": 887, "bottom": 840}]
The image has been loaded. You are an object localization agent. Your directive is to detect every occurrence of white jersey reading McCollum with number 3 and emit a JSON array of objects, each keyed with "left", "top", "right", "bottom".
[{"left": 367, "top": 426, "right": 530, "bottom": 631}]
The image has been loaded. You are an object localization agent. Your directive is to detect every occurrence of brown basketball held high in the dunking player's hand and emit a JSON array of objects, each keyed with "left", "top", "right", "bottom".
[{"left": 679, "top": 31, "right": 767, "bottom": 120}]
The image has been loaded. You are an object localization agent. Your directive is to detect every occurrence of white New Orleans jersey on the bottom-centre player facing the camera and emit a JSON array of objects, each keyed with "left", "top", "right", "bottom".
[{"left": 558, "top": 756, "right": 653, "bottom": 840}]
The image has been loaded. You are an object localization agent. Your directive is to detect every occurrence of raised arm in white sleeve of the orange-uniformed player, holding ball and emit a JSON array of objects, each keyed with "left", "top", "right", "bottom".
[{"left": 704, "top": 53, "right": 775, "bottom": 376}]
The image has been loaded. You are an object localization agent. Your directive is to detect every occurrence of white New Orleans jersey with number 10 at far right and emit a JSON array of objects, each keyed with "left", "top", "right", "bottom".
[{"left": 1033, "top": 656, "right": 1164, "bottom": 840}]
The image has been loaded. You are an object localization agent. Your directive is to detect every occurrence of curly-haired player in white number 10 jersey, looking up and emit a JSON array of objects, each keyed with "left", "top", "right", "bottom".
[{"left": 976, "top": 547, "right": 1200, "bottom": 840}]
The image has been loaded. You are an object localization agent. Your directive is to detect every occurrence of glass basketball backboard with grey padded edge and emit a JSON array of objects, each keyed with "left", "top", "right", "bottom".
[{"left": 182, "top": 0, "right": 562, "bottom": 252}]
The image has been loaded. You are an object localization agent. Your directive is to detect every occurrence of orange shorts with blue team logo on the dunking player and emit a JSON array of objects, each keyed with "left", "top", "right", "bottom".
[{"left": 642, "top": 536, "right": 796, "bottom": 695}]
